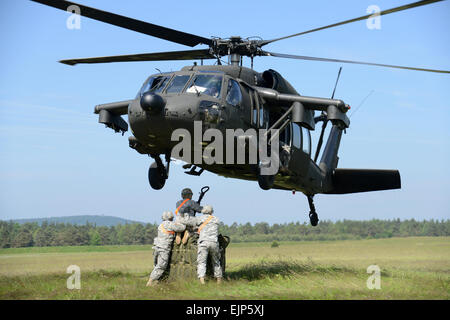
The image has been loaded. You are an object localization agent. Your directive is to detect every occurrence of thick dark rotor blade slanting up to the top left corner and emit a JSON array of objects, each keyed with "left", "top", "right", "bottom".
[{"left": 31, "top": 0, "right": 212, "bottom": 47}]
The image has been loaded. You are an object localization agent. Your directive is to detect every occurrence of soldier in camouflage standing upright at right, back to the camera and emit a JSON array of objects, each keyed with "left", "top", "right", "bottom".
[{"left": 195, "top": 206, "right": 222, "bottom": 284}]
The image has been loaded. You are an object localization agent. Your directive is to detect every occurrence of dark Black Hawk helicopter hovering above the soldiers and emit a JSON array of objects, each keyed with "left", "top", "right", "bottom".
[{"left": 32, "top": 0, "right": 450, "bottom": 226}]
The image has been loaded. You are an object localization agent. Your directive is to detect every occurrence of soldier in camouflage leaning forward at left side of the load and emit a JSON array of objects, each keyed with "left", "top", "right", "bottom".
[{"left": 147, "top": 211, "right": 186, "bottom": 287}]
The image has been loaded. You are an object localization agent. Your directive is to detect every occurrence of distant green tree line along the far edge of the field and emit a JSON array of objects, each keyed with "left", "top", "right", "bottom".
[{"left": 0, "top": 219, "right": 450, "bottom": 248}]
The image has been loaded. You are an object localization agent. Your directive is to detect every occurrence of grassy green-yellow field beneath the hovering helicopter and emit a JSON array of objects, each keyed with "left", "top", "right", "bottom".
[{"left": 0, "top": 237, "right": 450, "bottom": 299}]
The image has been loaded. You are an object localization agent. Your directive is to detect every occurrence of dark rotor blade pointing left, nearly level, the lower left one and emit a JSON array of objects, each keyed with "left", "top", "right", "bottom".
[{"left": 59, "top": 49, "right": 216, "bottom": 66}]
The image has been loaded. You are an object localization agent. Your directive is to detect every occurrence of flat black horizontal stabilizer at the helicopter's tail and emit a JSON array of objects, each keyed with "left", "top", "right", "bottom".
[{"left": 325, "top": 169, "right": 401, "bottom": 194}]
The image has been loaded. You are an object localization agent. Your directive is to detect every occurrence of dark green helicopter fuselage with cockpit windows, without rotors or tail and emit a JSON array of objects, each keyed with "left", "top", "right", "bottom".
[{"left": 128, "top": 65, "right": 322, "bottom": 193}]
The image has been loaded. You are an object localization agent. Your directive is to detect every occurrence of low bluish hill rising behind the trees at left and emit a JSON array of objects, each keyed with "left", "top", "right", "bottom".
[{"left": 6, "top": 215, "right": 144, "bottom": 227}]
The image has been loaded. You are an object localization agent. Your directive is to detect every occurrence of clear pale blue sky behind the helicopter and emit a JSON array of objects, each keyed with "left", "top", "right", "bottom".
[{"left": 0, "top": 0, "right": 450, "bottom": 224}]
